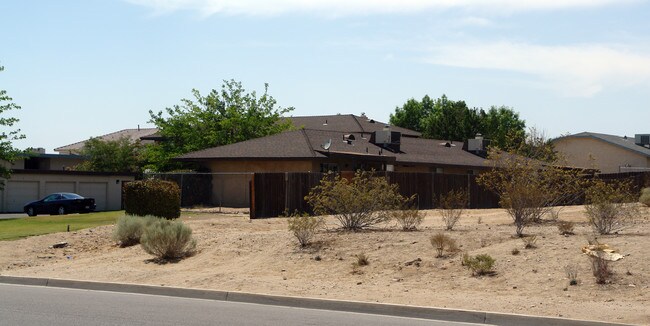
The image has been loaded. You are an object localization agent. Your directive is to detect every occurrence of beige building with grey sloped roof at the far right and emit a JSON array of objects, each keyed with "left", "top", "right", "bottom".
[{"left": 553, "top": 132, "right": 650, "bottom": 173}]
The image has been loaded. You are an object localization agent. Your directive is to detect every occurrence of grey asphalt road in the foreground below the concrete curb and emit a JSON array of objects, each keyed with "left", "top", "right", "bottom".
[{"left": 0, "top": 284, "right": 486, "bottom": 326}]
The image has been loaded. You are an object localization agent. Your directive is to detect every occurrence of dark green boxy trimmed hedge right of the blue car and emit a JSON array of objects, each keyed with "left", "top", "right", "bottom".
[{"left": 124, "top": 179, "right": 181, "bottom": 220}]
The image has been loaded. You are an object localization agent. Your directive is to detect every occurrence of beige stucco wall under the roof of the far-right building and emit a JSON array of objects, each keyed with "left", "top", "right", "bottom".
[{"left": 553, "top": 138, "right": 650, "bottom": 173}]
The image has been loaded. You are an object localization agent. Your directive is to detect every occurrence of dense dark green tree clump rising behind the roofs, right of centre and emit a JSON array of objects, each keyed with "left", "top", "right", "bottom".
[{"left": 390, "top": 94, "right": 526, "bottom": 150}]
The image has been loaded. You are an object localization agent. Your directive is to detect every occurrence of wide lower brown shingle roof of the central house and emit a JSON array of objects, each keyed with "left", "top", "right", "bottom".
[{"left": 179, "top": 128, "right": 486, "bottom": 167}]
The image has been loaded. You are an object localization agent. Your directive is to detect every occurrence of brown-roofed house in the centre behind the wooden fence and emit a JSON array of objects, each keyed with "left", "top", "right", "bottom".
[{"left": 177, "top": 115, "right": 487, "bottom": 207}]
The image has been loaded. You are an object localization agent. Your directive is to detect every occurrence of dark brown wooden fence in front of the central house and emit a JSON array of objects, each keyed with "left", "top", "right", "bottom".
[{"left": 250, "top": 172, "right": 499, "bottom": 218}]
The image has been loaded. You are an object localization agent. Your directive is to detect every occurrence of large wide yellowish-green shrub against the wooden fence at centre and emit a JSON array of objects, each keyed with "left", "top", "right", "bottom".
[{"left": 305, "top": 171, "right": 405, "bottom": 231}]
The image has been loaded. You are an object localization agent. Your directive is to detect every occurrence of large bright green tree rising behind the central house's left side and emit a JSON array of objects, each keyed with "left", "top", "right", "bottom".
[{"left": 147, "top": 80, "right": 293, "bottom": 171}]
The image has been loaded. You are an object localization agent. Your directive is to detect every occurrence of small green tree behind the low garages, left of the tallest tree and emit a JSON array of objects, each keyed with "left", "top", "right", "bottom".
[{"left": 75, "top": 137, "right": 143, "bottom": 173}]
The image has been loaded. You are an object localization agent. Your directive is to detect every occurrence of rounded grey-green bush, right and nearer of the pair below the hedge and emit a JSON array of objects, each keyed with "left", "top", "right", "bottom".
[{"left": 140, "top": 219, "right": 196, "bottom": 259}]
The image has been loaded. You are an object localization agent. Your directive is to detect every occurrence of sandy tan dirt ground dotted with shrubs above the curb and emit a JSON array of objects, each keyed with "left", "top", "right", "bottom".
[{"left": 0, "top": 206, "right": 650, "bottom": 325}]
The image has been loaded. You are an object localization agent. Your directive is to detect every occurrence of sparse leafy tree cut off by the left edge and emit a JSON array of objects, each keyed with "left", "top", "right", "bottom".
[{"left": 0, "top": 66, "right": 25, "bottom": 189}]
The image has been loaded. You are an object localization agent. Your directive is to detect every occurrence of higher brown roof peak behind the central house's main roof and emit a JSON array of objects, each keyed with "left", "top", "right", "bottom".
[{"left": 286, "top": 114, "right": 422, "bottom": 137}]
